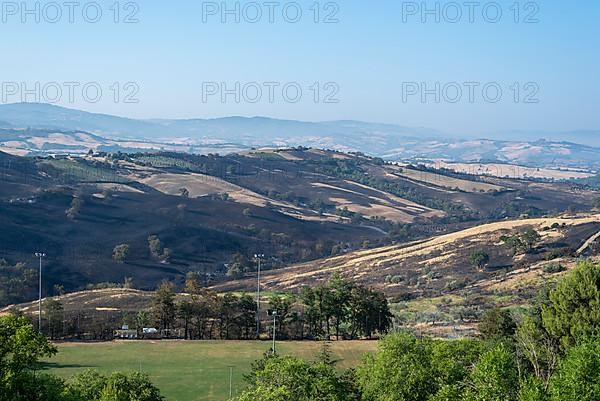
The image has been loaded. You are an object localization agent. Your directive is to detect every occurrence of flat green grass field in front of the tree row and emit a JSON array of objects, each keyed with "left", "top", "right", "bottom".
[{"left": 47, "top": 341, "right": 377, "bottom": 401}]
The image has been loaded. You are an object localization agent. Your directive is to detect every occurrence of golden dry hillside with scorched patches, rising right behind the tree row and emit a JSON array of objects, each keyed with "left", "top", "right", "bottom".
[{"left": 212, "top": 214, "right": 600, "bottom": 338}]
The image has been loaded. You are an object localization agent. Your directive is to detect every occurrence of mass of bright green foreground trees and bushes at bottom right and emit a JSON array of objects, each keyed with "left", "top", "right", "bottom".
[{"left": 240, "top": 262, "right": 600, "bottom": 401}]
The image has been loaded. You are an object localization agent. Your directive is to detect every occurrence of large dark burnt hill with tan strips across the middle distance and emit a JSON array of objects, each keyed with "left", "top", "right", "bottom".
[{"left": 0, "top": 148, "right": 597, "bottom": 303}]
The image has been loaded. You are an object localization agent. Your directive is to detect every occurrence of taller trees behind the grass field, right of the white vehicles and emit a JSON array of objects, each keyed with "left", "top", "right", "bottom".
[{"left": 149, "top": 273, "right": 392, "bottom": 340}]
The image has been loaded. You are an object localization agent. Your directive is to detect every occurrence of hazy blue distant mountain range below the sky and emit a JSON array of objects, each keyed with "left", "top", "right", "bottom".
[{"left": 0, "top": 103, "right": 600, "bottom": 170}]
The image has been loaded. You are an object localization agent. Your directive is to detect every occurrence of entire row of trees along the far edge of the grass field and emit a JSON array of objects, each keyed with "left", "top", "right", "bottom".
[{"left": 32, "top": 272, "right": 393, "bottom": 340}]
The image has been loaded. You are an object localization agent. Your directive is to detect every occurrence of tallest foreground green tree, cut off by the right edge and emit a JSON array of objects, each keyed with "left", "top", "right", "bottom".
[{"left": 542, "top": 261, "right": 600, "bottom": 350}]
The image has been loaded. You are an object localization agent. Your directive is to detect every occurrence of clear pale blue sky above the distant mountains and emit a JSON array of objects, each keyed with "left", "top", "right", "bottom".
[{"left": 0, "top": 0, "right": 600, "bottom": 135}]
